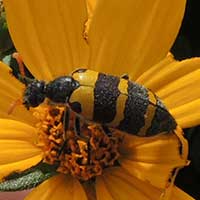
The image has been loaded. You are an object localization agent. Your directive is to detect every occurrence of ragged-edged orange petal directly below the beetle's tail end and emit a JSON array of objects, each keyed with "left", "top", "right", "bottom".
[{"left": 120, "top": 131, "right": 187, "bottom": 189}]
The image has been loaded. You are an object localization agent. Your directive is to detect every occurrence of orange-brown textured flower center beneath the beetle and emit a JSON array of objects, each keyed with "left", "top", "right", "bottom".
[{"left": 35, "top": 106, "right": 123, "bottom": 180}]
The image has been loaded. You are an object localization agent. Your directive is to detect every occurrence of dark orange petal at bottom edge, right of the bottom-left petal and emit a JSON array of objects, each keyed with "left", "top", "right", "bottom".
[{"left": 96, "top": 168, "right": 164, "bottom": 200}]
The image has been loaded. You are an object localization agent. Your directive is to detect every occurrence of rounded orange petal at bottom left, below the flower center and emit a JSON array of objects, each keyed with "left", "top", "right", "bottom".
[{"left": 25, "top": 175, "right": 87, "bottom": 200}]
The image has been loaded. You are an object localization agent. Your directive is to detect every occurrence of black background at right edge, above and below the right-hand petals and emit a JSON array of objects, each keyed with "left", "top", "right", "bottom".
[{"left": 172, "top": 0, "right": 200, "bottom": 200}]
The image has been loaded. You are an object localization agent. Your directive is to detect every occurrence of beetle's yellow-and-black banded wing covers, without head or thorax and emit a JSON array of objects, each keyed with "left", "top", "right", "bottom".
[{"left": 70, "top": 70, "right": 176, "bottom": 136}]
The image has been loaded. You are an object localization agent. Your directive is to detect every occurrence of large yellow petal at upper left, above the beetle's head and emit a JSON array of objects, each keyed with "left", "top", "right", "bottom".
[{"left": 4, "top": 0, "right": 88, "bottom": 80}]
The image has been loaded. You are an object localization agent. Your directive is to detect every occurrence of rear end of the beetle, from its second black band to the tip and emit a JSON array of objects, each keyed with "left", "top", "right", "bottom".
[{"left": 117, "top": 81, "right": 176, "bottom": 136}]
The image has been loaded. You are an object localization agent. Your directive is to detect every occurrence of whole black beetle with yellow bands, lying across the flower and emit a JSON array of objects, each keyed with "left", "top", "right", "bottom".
[{"left": 23, "top": 69, "right": 177, "bottom": 136}]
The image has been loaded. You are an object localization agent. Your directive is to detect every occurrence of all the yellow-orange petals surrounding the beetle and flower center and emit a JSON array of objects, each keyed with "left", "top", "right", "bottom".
[{"left": 0, "top": 0, "right": 200, "bottom": 200}]
